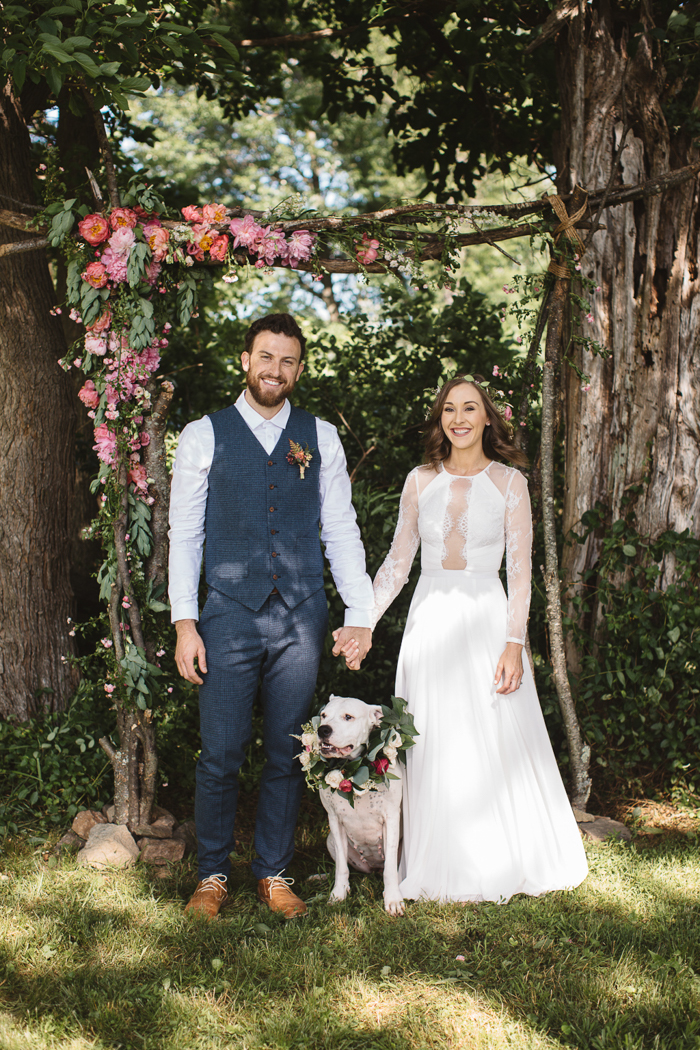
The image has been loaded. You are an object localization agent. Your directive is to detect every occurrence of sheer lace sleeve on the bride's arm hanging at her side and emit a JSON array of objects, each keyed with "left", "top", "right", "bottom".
[{"left": 506, "top": 470, "right": 532, "bottom": 646}]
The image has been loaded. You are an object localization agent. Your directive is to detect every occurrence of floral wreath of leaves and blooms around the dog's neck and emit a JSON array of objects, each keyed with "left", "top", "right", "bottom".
[{"left": 295, "top": 696, "right": 418, "bottom": 805}]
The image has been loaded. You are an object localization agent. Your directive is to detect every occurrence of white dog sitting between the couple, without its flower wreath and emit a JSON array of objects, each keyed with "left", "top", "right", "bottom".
[{"left": 317, "top": 695, "right": 404, "bottom": 916}]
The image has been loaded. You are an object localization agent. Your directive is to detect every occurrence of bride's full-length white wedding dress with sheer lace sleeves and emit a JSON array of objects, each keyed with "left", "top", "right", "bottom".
[{"left": 374, "top": 462, "right": 588, "bottom": 902}]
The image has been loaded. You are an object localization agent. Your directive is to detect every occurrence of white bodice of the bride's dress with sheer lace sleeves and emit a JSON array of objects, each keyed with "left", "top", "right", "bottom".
[{"left": 373, "top": 462, "right": 532, "bottom": 645}]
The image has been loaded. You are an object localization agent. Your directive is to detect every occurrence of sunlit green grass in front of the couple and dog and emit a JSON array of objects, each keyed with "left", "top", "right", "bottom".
[{"left": 0, "top": 810, "right": 700, "bottom": 1050}]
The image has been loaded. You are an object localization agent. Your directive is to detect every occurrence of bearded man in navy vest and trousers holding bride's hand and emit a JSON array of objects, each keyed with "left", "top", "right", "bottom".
[{"left": 170, "top": 314, "right": 373, "bottom": 918}]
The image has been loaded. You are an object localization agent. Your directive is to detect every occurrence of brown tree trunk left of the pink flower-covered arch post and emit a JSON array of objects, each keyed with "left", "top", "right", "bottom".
[{"left": 0, "top": 77, "right": 76, "bottom": 719}]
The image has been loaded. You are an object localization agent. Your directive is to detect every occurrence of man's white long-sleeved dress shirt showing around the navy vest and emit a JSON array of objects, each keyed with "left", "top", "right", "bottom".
[{"left": 169, "top": 393, "right": 374, "bottom": 627}]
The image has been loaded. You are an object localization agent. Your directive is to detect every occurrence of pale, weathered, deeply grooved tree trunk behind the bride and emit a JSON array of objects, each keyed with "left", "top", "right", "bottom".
[{"left": 557, "top": 2, "right": 700, "bottom": 585}]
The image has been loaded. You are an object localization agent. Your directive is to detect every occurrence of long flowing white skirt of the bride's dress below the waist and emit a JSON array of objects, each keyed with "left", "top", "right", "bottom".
[{"left": 396, "top": 571, "right": 588, "bottom": 902}]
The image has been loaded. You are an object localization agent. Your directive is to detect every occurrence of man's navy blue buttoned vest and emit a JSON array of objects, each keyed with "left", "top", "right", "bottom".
[{"left": 205, "top": 404, "right": 323, "bottom": 611}]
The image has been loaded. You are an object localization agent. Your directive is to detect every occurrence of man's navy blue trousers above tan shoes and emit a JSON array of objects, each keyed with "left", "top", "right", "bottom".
[{"left": 194, "top": 588, "right": 328, "bottom": 879}]
